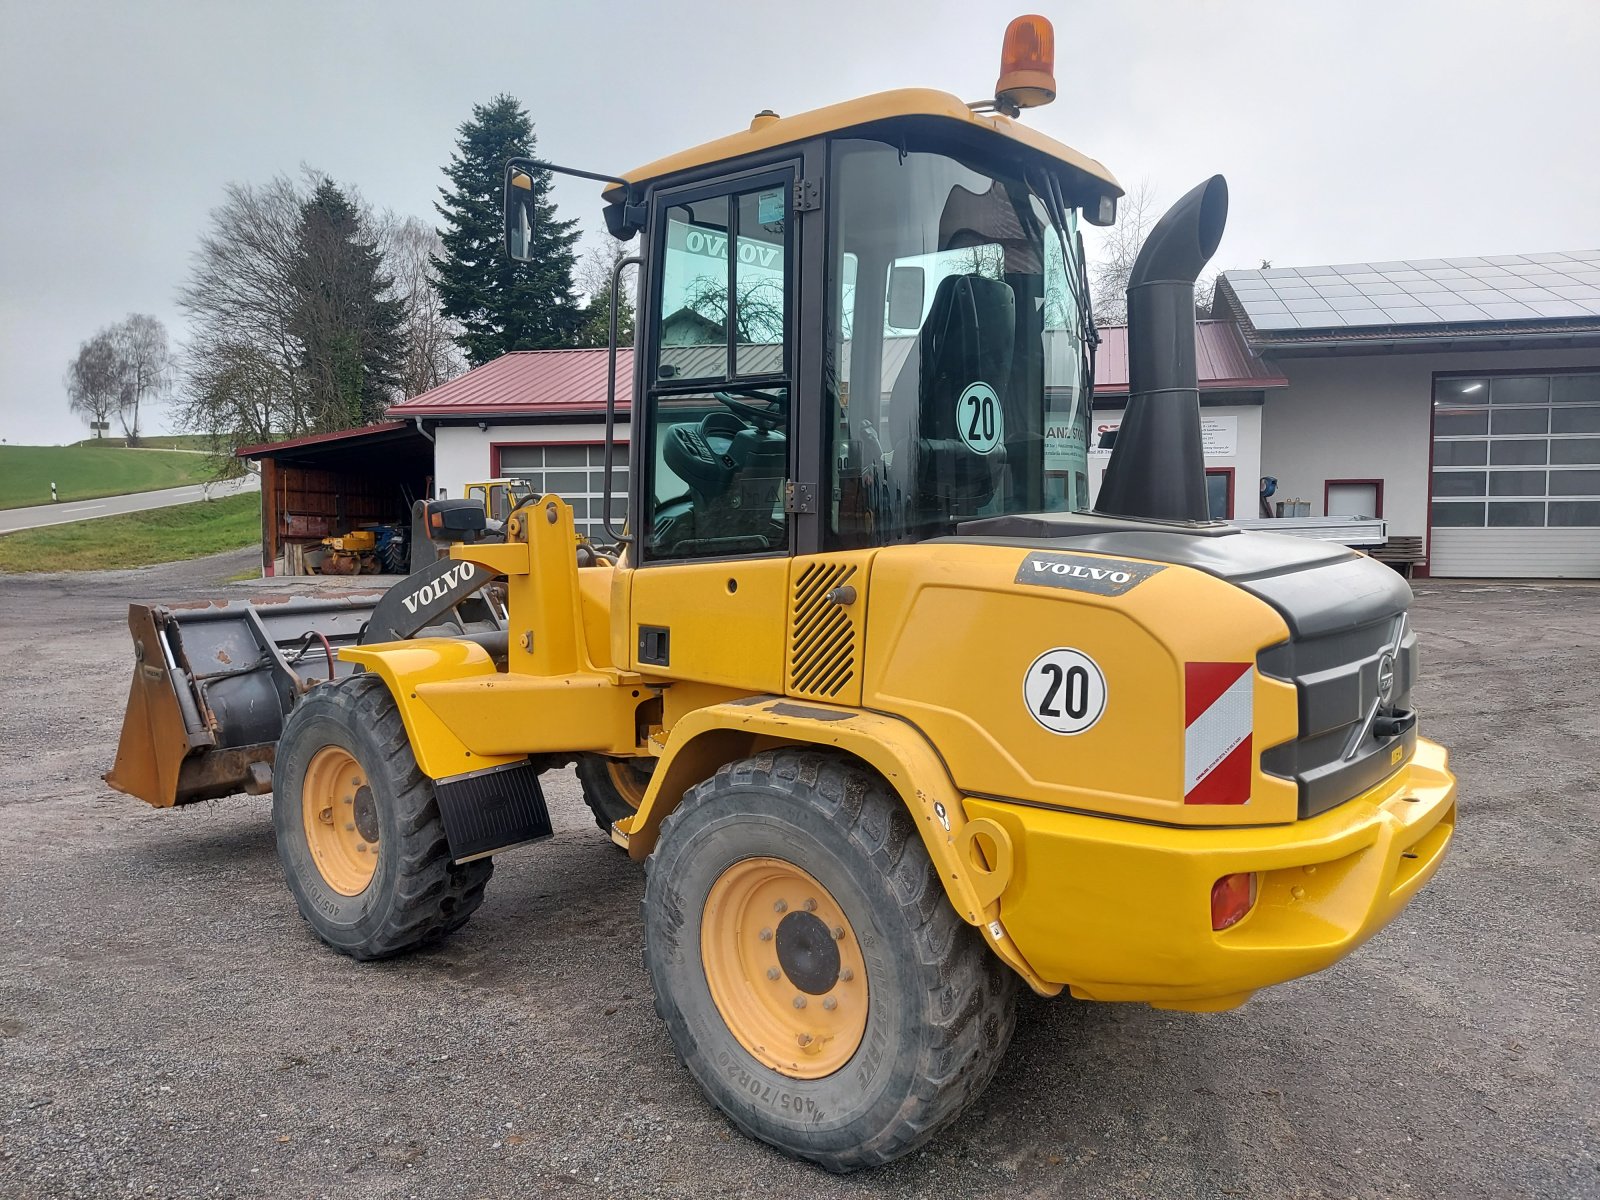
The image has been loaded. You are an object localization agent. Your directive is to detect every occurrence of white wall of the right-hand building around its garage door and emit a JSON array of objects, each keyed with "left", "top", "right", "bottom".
[{"left": 1259, "top": 350, "right": 1600, "bottom": 538}]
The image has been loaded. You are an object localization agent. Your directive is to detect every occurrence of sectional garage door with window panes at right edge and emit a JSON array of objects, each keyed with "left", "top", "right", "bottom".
[{"left": 1429, "top": 373, "right": 1600, "bottom": 579}]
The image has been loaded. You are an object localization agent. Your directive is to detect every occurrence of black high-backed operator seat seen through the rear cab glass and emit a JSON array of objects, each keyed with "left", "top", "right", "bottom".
[{"left": 890, "top": 274, "right": 1016, "bottom": 539}]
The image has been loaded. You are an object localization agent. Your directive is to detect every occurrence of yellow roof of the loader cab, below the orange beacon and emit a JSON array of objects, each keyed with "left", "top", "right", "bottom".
[{"left": 605, "top": 88, "right": 1123, "bottom": 200}]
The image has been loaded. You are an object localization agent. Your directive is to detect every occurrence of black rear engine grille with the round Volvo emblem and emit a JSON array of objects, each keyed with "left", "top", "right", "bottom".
[{"left": 1258, "top": 610, "right": 1418, "bottom": 818}]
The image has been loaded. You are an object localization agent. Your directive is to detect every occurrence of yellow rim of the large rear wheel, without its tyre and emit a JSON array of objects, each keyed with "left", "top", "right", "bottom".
[{"left": 701, "top": 858, "right": 867, "bottom": 1078}]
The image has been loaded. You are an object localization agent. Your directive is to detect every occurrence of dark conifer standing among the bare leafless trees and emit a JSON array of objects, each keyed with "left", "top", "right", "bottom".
[{"left": 290, "top": 179, "right": 405, "bottom": 430}]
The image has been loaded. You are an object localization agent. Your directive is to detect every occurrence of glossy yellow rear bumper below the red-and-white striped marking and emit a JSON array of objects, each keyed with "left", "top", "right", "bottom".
[{"left": 966, "top": 739, "right": 1456, "bottom": 1010}]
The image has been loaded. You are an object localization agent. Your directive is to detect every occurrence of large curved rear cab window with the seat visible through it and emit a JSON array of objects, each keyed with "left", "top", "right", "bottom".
[{"left": 829, "top": 139, "right": 1093, "bottom": 547}]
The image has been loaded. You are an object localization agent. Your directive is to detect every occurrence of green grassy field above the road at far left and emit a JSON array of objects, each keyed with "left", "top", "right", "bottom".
[{"left": 0, "top": 446, "right": 225, "bottom": 509}]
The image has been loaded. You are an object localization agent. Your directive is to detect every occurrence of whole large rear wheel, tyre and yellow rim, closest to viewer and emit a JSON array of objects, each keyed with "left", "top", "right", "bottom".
[{"left": 643, "top": 750, "right": 1016, "bottom": 1171}]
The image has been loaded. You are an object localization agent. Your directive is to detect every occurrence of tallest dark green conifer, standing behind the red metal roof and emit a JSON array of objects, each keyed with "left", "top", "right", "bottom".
[{"left": 434, "top": 94, "right": 581, "bottom": 366}]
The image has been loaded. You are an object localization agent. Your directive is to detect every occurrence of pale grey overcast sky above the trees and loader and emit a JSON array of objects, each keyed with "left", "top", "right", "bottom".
[{"left": 0, "top": 0, "right": 1600, "bottom": 443}]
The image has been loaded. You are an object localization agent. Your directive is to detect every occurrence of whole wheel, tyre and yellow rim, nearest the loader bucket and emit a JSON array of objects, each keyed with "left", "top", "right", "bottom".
[{"left": 272, "top": 674, "right": 494, "bottom": 960}]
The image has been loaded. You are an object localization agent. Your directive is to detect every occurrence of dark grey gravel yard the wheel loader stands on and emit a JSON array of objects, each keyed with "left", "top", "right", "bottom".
[{"left": 0, "top": 552, "right": 1600, "bottom": 1197}]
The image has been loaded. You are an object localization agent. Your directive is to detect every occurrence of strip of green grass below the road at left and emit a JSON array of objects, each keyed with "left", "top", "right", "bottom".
[{"left": 0, "top": 491, "right": 261, "bottom": 571}]
